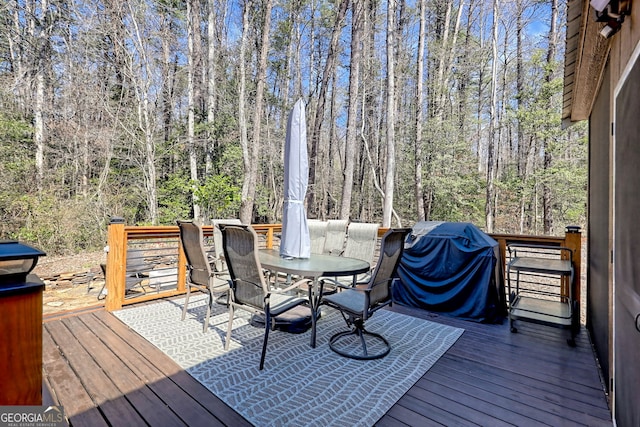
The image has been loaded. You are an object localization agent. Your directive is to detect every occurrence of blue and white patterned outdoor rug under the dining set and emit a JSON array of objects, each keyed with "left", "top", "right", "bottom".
[{"left": 114, "top": 295, "right": 463, "bottom": 427}]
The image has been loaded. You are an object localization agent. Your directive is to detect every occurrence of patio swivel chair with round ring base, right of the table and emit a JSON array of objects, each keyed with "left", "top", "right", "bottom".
[{"left": 323, "top": 228, "right": 411, "bottom": 360}]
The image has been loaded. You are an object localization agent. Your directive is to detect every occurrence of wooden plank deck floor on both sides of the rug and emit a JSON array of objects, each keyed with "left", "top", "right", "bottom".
[{"left": 43, "top": 305, "right": 613, "bottom": 427}]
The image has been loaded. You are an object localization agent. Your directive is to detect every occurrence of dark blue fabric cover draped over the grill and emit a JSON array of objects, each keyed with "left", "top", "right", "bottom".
[{"left": 393, "top": 221, "right": 506, "bottom": 323}]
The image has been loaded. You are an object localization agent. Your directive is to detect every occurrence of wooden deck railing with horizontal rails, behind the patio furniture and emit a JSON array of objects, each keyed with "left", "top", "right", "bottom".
[{"left": 105, "top": 218, "right": 581, "bottom": 311}]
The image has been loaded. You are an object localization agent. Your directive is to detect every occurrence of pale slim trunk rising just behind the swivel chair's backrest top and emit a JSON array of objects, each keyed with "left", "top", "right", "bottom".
[{"left": 382, "top": 0, "right": 397, "bottom": 227}]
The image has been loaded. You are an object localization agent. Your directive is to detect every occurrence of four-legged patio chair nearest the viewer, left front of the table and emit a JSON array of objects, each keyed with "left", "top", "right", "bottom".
[{"left": 220, "top": 225, "right": 309, "bottom": 370}]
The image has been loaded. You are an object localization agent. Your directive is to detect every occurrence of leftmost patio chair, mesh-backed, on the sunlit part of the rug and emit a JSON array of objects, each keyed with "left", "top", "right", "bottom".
[{"left": 178, "top": 221, "right": 229, "bottom": 332}]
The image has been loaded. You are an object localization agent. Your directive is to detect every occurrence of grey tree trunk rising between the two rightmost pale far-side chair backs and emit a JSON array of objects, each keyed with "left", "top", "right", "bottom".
[{"left": 340, "top": 0, "right": 364, "bottom": 220}]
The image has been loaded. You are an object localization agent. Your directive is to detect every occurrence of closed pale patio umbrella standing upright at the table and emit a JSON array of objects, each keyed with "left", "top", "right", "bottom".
[{"left": 280, "top": 99, "right": 311, "bottom": 258}]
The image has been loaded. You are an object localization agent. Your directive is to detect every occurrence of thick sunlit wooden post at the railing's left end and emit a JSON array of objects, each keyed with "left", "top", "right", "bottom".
[{"left": 105, "top": 217, "right": 127, "bottom": 311}]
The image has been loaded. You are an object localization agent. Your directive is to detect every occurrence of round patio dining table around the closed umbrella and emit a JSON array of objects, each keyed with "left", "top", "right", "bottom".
[{"left": 259, "top": 249, "right": 371, "bottom": 348}]
